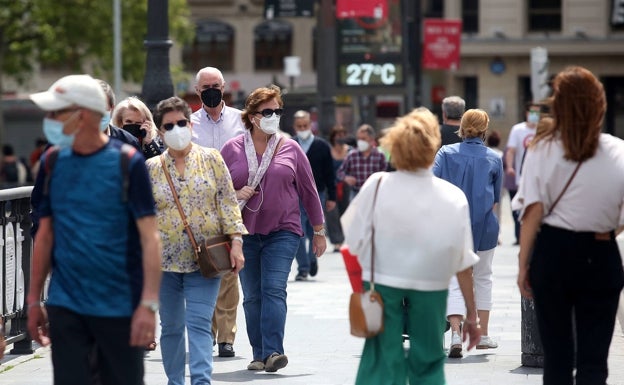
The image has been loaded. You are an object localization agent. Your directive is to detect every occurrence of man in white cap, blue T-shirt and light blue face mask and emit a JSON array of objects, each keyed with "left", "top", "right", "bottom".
[{"left": 27, "top": 75, "right": 161, "bottom": 385}]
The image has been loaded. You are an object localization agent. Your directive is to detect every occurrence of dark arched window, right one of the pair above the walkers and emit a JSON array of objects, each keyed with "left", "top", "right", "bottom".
[{"left": 254, "top": 20, "right": 293, "bottom": 71}]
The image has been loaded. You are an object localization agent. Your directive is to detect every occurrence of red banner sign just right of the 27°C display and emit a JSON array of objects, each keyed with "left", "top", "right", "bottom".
[{"left": 422, "top": 19, "right": 462, "bottom": 70}]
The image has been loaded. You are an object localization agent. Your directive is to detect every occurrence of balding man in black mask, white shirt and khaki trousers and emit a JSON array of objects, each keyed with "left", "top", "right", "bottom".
[{"left": 191, "top": 67, "right": 245, "bottom": 357}]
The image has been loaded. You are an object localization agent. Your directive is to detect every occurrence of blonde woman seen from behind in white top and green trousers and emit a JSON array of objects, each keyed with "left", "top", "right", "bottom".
[{"left": 341, "top": 108, "right": 480, "bottom": 385}]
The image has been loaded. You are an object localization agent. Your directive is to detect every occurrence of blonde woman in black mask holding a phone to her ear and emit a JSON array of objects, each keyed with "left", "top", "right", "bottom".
[{"left": 111, "top": 96, "right": 164, "bottom": 159}]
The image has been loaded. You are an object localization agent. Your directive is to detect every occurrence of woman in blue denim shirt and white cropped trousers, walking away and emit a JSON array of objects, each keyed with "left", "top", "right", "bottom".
[{"left": 433, "top": 109, "right": 503, "bottom": 358}]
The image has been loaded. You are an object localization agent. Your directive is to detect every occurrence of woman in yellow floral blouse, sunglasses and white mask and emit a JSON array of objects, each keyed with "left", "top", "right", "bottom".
[{"left": 147, "top": 97, "right": 247, "bottom": 385}]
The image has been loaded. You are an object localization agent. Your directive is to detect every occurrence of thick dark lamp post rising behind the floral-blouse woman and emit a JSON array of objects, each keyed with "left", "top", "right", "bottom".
[{"left": 141, "top": 0, "right": 173, "bottom": 110}]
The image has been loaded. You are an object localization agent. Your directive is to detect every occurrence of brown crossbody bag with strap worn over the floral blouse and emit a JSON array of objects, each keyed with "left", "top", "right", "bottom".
[{"left": 160, "top": 154, "right": 234, "bottom": 278}]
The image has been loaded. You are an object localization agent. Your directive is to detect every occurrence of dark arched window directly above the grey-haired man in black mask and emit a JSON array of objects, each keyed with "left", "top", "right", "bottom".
[{"left": 182, "top": 20, "right": 234, "bottom": 72}]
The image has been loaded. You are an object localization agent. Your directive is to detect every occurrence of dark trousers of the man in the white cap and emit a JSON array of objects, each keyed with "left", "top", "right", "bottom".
[{"left": 47, "top": 306, "right": 144, "bottom": 385}]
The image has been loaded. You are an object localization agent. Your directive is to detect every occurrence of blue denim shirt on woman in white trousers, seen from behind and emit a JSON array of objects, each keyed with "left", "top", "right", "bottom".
[{"left": 433, "top": 138, "right": 503, "bottom": 251}]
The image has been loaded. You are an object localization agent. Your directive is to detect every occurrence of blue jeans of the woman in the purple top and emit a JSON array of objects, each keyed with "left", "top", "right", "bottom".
[{"left": 239, "top": 230, "right": 299, "bottom": 361}]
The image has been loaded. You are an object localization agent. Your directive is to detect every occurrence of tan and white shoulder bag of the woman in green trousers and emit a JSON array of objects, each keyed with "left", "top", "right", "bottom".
[{"left": 349, "top": 177, "right": 384, "bottom": 338}]
